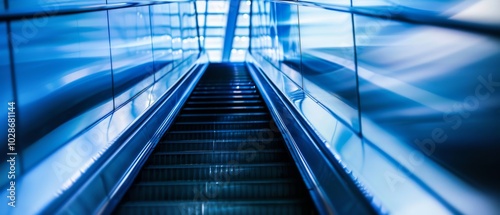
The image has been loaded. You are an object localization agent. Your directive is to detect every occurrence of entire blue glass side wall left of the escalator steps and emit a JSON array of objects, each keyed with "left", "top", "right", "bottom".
[{"left": 0, "top": 0, "right": 200, "bottom": 214}]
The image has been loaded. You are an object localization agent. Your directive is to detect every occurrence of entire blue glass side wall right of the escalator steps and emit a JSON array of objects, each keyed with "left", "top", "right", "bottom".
[{"left": 248, "top": 0, "right": 500, "bottom": 214}]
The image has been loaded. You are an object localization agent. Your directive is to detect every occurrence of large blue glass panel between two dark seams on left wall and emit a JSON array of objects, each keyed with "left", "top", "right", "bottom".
[{"left": 12, "top": 12, "right": 112, "bottom": 168}]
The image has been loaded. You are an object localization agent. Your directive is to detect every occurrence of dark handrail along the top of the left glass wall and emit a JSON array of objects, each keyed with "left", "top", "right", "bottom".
[{"left": 0, "top": 0, "right": 194, "bottom": 21}]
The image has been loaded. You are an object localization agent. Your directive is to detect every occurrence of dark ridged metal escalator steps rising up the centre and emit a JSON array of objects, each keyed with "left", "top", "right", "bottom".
[{"left": 114, "top": 64, "right": 317, "bottom": 214}]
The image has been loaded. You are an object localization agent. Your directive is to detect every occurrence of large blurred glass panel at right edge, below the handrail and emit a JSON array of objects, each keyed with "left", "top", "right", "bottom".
[{"left": 355, "top": 16, "right": 500, "bottom": 207}]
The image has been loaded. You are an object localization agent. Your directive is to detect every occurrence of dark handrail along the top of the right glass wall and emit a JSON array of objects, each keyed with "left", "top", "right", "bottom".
[{"left": 264, "top": 0, "right": 500, "bottom": 37}]
